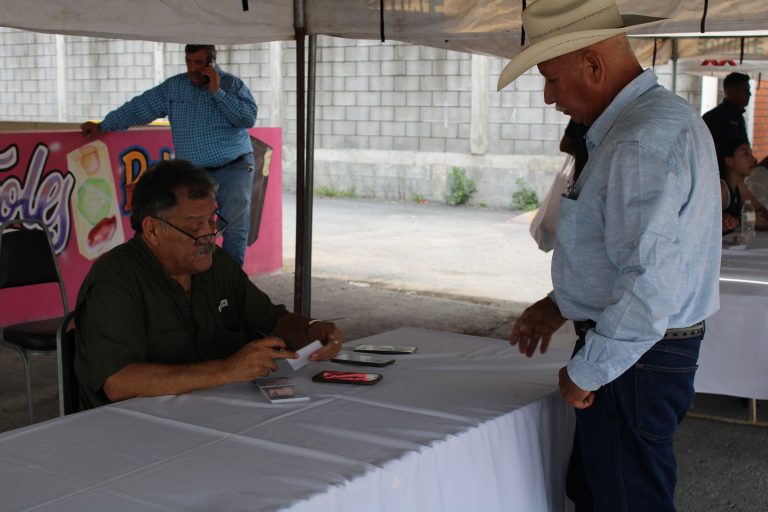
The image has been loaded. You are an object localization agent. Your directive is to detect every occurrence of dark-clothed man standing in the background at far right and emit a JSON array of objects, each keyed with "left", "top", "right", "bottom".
[{"left": 704, "top": 73, "right": 752, "bottom": 147}]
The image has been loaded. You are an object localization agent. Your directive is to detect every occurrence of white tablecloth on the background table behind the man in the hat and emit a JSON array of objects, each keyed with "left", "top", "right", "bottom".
[{"left": 695, "top": 232, "right": 768, "bottom": 400}]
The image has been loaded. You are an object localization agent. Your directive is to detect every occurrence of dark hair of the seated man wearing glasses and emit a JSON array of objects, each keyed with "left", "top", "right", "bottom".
[{"left": 131, "top": 160, "right": 216, "bottom": 233}]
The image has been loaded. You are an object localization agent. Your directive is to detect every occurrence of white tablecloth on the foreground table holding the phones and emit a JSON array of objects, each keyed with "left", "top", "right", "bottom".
[{"left": 0, "top": 329, "right": 574, "bottom": 512}]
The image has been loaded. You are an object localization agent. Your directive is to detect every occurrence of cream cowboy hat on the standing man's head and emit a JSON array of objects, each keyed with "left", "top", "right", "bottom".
[{"left": 498, "top": 0, "right": 667, "bottom": 91}]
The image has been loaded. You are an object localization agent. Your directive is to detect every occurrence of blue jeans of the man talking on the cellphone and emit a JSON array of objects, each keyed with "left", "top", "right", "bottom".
[{"left": 208, "top": 153, "right": 254, "bottom": 266}]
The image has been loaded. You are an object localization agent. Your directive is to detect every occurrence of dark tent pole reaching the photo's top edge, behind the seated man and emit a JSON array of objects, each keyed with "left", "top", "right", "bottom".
[{"left": 293, "top": 0, "right": 312, "bottom": 316}]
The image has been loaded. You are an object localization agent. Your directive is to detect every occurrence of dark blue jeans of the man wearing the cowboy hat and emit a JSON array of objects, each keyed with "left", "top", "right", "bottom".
[{"left": 566, "top": 337, "right": 702, "bottom": 512}]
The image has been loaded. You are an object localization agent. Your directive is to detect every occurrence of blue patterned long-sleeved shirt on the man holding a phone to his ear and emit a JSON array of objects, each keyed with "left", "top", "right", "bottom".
[{"left": 101, "top": 67, "right": 258, "bottom": 167}]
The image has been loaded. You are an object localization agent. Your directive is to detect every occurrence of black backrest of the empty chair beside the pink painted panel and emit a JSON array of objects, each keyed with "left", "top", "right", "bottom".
[{"left": 0, "top": 220, "right": 59, "bottom": 288}]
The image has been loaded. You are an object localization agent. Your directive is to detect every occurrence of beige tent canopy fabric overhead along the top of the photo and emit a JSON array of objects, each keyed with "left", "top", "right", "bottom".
[{"left": 0, "top": 0, "right": 768, "bottom": 62}]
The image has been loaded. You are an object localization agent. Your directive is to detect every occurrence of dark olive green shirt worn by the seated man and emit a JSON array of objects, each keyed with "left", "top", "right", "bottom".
[{"left": 75, "top": 235, "right": 285, "bottom": 409}]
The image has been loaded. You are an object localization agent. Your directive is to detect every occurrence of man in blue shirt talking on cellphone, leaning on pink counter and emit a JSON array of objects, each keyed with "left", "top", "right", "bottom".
[{"left": 80, "top": 44, "right": 258, "bottom": 266}]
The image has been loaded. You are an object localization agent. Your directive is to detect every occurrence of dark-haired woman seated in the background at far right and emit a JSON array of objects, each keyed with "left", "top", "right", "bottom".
[{"left": 717, "top": 138, "right": 768, "bottom": 234}]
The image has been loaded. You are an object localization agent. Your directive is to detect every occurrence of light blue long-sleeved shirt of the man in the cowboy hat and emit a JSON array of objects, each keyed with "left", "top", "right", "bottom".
[{"left": 551, "top": 70, "right": 722, "bottom": 390}]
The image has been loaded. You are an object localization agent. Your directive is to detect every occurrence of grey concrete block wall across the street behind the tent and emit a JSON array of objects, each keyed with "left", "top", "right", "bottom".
[{"left": 0, "top": 28, "right": 700, "bottom": 207}]
